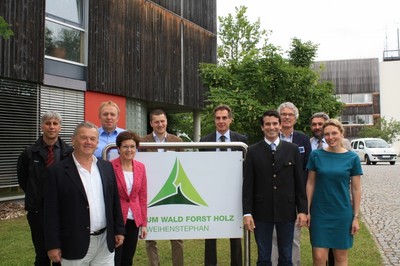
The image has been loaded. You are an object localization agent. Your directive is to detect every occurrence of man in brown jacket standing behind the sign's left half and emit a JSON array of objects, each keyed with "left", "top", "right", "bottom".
[{"left": 140, "top": 109, "right": 184, "bottom": 266}]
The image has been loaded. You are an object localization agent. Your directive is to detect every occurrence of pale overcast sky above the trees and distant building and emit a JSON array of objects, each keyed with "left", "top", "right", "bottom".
[{"left": 217, "top": 0, "right": 400, "bottom": 61}]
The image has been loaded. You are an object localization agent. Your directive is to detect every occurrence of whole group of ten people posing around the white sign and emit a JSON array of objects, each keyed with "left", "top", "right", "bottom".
[{"left": 17, "top": 101, "right": 362, "bottom": 266}]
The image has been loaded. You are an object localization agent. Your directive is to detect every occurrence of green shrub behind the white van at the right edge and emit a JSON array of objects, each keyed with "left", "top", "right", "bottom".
[{"left": 358, "top": 117, "right": 400, "bottom": 143}]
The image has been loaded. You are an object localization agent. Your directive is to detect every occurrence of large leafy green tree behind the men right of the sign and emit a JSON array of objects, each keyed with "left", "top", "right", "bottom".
[{"left": 200, "top": 6, "right": 343, "bottom": 143}]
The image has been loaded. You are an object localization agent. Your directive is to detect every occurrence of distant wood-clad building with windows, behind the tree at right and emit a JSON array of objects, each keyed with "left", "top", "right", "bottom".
[{"left": 314, "top": 58, "right": 380, "bottom": 138}]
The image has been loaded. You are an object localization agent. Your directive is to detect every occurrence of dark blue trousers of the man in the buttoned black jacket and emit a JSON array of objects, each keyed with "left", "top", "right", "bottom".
[{"left": 254, "top": 221, "right": 294, "bottom": 266}]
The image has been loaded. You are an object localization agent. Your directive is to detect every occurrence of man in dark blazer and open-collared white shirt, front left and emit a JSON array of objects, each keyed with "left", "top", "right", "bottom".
[{"left": 44, "top": 122, "right": 125, "bottom": 266}]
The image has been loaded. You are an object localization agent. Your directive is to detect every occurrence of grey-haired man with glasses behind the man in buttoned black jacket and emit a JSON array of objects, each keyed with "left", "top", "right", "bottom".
[{"left": 272, "top": 102, "right": 311, "bottom": 266}]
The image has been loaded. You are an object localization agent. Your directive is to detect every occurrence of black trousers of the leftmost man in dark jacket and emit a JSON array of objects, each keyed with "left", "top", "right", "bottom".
[{"left": 27, "top": 211, "right": 61, "bottom": 266}]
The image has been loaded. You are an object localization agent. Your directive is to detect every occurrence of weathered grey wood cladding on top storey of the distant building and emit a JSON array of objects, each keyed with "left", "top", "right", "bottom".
[{"left": 316, "top": 58, "right": 379, "bottom": 94}]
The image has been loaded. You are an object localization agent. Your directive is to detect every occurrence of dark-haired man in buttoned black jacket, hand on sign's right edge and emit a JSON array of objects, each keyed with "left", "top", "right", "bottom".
[{"left": 243, "top": 110, "right": 308, "bottom": 265}]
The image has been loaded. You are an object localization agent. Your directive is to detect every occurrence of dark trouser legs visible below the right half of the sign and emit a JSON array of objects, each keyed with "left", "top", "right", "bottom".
[{"left": 204, "top": 238, "right": 243, "bottom": 266}]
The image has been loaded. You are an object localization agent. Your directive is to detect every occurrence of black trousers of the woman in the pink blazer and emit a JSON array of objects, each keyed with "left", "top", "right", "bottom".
[{"left": 114, "top": 219, "right": 139, "bottom": 266}]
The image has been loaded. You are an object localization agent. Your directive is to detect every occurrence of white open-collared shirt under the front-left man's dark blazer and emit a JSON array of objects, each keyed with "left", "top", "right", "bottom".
[{"left": 72, "top": 153, "right": 107, "bottom": 232}]
